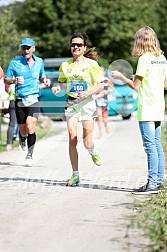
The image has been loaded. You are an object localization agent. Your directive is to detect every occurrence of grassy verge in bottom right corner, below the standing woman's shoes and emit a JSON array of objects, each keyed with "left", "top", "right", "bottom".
[{"left": 138, "top": 191, "right": 167, "bottom": 252}]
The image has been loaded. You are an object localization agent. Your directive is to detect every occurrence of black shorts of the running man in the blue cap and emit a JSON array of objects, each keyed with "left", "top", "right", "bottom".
[{"left": 15, "top": 100, "right": 41, "bottom": 124}]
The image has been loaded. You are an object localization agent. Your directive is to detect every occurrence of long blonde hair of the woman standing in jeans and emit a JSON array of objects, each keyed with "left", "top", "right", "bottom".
[{"left": 132, "top": 26, "right": 163, "bottom": 57}]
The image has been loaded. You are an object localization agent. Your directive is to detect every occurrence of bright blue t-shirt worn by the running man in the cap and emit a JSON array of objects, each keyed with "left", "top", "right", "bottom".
[{"left": 6, "top": 54, "right": 45, "bottom": 99}]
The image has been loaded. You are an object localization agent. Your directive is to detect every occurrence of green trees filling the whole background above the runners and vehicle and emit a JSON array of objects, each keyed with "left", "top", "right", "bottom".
[{"left": 0, "top": 0, "right": 167, "bottom": 70}]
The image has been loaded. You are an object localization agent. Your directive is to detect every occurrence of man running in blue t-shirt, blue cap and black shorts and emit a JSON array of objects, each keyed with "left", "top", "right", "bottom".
[{"left": 5, "top": 38, "right": 50, "bottom": 166}]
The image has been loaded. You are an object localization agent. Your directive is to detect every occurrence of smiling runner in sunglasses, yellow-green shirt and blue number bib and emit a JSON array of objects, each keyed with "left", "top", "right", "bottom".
[{"left": 52, "top": 32, "right": 104, "bottom": 186}]
